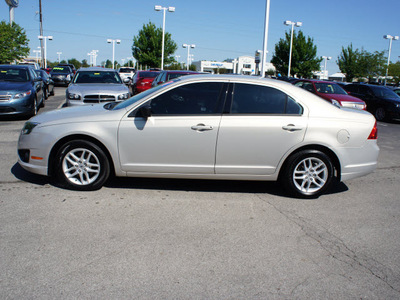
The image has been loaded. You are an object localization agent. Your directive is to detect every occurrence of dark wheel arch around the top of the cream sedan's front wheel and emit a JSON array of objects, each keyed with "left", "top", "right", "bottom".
[{"left": 47, "top": 134, "right": 115, "bottom": 176}]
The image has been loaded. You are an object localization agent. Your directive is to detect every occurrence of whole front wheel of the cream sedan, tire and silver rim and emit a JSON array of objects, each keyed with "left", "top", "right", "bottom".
[{"left": 55, "top": 140, "right": 110, "bottom": 191}]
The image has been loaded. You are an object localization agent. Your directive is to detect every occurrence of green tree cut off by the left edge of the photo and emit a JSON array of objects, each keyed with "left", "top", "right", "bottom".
[{"left": 0, "top": 21, "right": 30, "bottom": 64}]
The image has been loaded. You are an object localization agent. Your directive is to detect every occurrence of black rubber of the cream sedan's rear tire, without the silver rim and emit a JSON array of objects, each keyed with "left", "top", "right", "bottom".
[{"left": 281, "top": 150, "right": 334, "bottom": 198}]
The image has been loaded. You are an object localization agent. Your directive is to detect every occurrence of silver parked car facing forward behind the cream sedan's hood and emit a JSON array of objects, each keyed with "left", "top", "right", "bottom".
[{"left": 66, "top": 67, "right": 131, "bottom": 106}]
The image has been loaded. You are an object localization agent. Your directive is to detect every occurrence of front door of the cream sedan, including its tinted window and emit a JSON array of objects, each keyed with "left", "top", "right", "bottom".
[{"left": 118, "top": 82, "right": 226, "bottom": 174}]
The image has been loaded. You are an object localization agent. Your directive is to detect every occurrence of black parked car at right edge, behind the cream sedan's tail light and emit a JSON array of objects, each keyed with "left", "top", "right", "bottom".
[{"left": 345, "top": 83, "right": 400, "bottom": 121}]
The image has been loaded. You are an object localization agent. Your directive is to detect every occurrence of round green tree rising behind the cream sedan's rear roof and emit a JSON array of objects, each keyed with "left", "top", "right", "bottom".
[{"left": 271, "top": 30, "right": 322, "bottom": 77}]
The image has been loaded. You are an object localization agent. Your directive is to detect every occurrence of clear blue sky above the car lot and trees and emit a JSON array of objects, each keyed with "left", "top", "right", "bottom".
[{"left": 0, "top": 0, "right": 400, "bottom": 74}]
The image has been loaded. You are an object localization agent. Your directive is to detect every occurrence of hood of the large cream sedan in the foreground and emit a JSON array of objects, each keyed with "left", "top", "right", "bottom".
[{"left": 29, "top": 103, "right": 126, "bottom": 126}]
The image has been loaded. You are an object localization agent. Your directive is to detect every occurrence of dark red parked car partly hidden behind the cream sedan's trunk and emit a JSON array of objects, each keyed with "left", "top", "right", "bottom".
[{"left": 293, "top": 79, "right": 367, "bottom": 110}]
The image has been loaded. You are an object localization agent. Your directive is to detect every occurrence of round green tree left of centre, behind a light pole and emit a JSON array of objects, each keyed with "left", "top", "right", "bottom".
[{"left": 132, "top": 22, "right": 178, "bottom": 68}]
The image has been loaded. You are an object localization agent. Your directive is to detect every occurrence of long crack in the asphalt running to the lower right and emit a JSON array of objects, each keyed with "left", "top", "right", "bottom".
[{"left": 259, "top": 196, "right": 400, "bottom": 293}]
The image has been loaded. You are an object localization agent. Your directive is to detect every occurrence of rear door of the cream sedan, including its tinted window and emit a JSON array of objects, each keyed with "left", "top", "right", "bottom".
[{"left": 215, "top": 83, "right": 308, "bottom": 175}]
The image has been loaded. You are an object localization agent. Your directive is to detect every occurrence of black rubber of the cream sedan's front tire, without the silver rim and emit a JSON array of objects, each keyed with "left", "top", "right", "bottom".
[{"left": 55, "top": 140, "right": 110, "bottom": 191}]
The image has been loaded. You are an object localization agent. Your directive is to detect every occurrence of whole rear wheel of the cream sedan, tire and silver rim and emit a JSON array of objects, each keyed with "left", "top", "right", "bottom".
[{"left": 280, "top": 150, "right": 334, "bottom": 198}]
